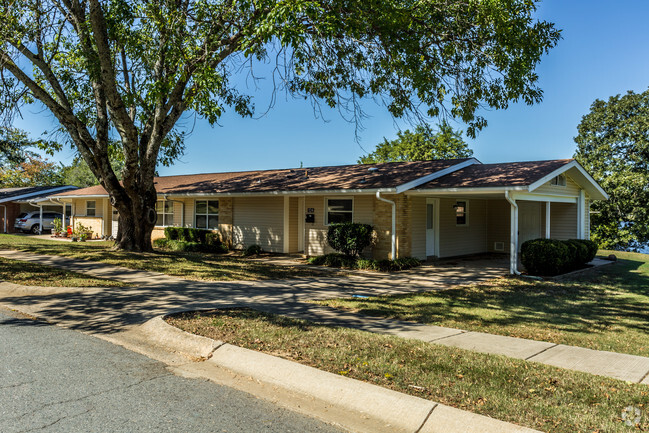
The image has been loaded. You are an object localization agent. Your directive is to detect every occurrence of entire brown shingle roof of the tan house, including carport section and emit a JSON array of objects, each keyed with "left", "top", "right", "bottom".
[{"left": 56, "top": 159, "right": 572, "bottom": 197}]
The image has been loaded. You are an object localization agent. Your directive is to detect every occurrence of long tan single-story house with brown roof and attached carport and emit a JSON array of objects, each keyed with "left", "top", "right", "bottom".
[{"left": 52, "top": 158, "right": 608, "bottom": 272}]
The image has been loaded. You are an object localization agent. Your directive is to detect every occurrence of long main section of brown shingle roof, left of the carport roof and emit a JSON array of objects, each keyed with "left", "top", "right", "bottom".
[{"left": 57, "top": 158, "right": 468, "bottom": 197}]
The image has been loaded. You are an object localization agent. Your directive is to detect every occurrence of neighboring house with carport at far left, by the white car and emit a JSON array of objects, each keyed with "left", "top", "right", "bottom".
[{"left": 0, "top": 185, "right": 77, "bottom": 233}]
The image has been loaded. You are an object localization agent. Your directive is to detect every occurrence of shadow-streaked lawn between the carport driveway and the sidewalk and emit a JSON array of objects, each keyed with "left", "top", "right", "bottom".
[{"left": 321, "top": 251, "right": 649, "bottom": 356}]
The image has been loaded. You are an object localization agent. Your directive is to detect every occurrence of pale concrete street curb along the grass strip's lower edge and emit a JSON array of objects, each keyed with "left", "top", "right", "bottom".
[{"left": 151, "top": 316, "right": 540, "bottom": 433}]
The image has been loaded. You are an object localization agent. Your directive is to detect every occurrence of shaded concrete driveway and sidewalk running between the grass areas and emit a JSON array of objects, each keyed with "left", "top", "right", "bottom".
[{"left": 0, "top": 250, "right": 649, "bottom": 384}]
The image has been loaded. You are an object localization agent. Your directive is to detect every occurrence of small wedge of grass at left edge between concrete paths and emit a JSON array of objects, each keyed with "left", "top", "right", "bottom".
[{"left": 0, "top": 257, "right": 126, "bottom": 287}]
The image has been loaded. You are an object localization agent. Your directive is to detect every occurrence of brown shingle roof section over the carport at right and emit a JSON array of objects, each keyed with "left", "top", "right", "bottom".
[{"left": 416, "top": 159, "right": 573, "bottom": 189}]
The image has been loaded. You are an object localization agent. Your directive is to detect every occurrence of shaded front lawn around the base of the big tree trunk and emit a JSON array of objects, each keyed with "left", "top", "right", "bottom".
[{"left": 0, "top": 235, "right": 330, "bottom": 281}]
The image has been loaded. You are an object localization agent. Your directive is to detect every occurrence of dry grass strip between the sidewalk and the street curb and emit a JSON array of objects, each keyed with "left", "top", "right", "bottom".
[{"left": 167, "top": 309, "right": 649, "bottom": 433}]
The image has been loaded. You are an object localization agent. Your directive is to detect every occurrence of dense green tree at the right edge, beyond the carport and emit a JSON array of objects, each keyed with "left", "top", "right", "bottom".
[{"left": 575, "top": 90, "right": 649, "bottom": 249}]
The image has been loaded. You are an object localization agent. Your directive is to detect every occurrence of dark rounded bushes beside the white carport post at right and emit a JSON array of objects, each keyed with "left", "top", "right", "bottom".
[{"left": 521, "top": 239, "right": 598, "bottom": 276}]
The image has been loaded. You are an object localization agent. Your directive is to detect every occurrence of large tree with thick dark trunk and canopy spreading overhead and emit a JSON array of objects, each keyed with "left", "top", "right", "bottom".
[{"left": 0, "top": 0, "right": 560, "bottom": 250}]
